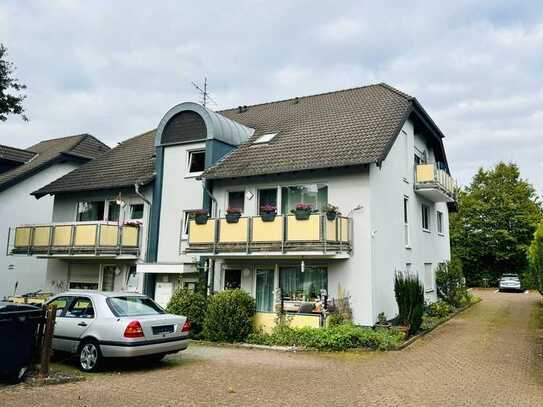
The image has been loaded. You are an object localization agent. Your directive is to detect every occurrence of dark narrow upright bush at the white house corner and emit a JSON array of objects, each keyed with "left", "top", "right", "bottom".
[{"left": 394, "top": 272, "right": 424, "bottom": 335}]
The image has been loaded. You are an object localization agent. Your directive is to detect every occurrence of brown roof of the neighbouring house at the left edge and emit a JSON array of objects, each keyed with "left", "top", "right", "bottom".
[{"left": 0, "top": 134, "right": 109, "bottom": 191}]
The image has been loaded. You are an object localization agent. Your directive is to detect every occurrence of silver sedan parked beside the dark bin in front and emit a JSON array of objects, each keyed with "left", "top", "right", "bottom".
[{"left": 47, "top": 291, "right": 190, "bottom": 372}]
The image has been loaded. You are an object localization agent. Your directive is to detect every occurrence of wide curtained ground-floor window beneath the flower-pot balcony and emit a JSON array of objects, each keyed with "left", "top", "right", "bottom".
[{"left": 280, "top": 266, "right": 328, "bottom": 301}]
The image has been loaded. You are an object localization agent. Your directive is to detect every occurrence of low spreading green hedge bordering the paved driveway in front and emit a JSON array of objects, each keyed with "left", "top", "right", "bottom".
[{"left": 248, "top": 323, "right": 404, "bottom": 351}]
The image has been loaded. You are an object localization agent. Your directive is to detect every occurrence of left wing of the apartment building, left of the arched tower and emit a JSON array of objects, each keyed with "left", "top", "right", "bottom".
[{"left": 12, "top": 132, "right": 154, "bottom": 302}]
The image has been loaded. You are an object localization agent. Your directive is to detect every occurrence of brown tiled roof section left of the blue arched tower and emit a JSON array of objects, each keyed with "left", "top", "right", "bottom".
[{"left": 32, "top": 130, "right": 155, "bottom": 197}]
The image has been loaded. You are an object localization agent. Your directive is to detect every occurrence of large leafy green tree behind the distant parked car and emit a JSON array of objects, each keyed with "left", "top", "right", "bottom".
[{"left": 451, "top": 162, "right": 542, "bottom": 285}]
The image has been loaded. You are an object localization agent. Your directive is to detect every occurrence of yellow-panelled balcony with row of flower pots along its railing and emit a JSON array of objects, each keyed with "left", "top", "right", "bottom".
[{"left": 184, "top": 214, "right": 352, "bottom": 258}]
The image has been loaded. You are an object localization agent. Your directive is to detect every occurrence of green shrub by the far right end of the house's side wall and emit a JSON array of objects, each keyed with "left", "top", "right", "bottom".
[{"left": 436, "top": 257, "right": 467, "bottom": 307}]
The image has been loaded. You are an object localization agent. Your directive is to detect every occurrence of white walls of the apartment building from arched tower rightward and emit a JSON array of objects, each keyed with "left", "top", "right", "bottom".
[{"left": 156, "top": 120, "right": 450, "bottom": 325}]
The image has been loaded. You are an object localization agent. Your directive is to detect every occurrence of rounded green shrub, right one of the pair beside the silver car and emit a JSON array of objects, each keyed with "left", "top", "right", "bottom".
[{"left": 204, "top": 288, "right": 256, "bottom": 342}]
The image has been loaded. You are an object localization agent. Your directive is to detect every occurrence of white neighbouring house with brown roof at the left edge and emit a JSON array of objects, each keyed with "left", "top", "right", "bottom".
[{"left": 0, "top": 134, "right": 109, "bottom": 299}]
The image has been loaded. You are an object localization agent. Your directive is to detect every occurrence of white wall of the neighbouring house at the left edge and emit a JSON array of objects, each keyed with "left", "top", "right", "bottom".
[{"left": 0, "top": 163, "right": 79, "bottom": 299}]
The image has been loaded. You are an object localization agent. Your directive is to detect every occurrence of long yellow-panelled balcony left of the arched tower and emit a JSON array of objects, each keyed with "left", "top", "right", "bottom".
[{"left": 8, "top": 222, "right": 140, "bottom": 257}]
